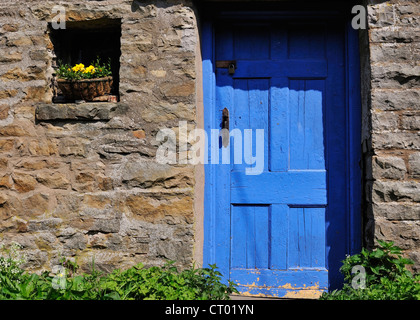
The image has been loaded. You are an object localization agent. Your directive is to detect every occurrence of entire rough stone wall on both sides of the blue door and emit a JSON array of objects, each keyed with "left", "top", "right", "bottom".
[{"left": 0, "top": 0, "right": 420, "bottom": 276}]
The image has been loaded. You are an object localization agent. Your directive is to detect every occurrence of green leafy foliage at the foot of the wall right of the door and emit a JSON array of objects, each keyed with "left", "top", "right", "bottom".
[{"left": 320, "top": 241, "right": 420, "bottom": 300}]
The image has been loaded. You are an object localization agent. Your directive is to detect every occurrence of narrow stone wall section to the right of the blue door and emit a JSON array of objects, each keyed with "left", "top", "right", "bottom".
[{"left": 364, "top": 0, "right": 420, "bottom": 270}]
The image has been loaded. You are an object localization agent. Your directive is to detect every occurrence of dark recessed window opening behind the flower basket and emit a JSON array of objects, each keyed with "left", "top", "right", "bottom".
[{"left": 48, "top": 18, "right": 121, "bottom": 103}]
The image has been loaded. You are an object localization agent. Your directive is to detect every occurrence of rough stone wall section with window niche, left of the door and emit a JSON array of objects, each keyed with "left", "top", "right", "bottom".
[{"left": 0, "top": 0, "right": 197, "bottom": 270}]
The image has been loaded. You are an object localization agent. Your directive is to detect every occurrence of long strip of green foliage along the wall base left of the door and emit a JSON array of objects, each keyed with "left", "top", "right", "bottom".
[{"left": 0, "top": 245, "right": 238, "bottom": 300}]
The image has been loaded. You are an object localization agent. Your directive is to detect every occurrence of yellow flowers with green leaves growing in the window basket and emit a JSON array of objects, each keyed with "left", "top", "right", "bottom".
[{"left": 57, "top": 57, "right": 112, "bottom": 81}]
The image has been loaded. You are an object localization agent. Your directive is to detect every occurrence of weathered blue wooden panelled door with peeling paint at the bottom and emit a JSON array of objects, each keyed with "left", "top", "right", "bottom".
[{"left": 212, "top": 21, "right": 347, "bottom": 297}]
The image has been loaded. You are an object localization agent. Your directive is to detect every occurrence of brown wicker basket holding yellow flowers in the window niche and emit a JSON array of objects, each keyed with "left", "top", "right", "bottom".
[{"left": 57, "top": 77, "right": 112, "bottom": 101}]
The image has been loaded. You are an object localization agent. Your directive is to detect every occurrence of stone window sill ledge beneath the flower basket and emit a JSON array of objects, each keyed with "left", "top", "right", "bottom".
[{"left": 35, "top": 102, "right": 127, "bottom": 121}]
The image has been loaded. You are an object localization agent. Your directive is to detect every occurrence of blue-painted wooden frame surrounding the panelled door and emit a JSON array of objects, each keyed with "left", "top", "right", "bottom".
[{"left": 200, "top": 5, "right": 362, "bottom": 289}]
